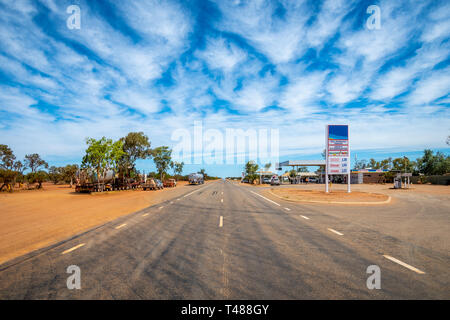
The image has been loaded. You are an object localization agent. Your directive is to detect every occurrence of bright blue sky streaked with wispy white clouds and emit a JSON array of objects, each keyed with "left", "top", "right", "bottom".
[{"left": 0, "top": 0, "right": 450, "bottom": 176}]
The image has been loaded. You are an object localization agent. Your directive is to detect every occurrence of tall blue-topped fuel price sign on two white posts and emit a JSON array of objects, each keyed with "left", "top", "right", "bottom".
[{"left": 325, "top": 125, "right": 351, "bottom": 192}]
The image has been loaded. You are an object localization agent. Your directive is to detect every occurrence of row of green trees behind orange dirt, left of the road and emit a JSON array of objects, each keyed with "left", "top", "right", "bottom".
[{"left": 0, "top": 132, "right": 213, "bottom": 191}]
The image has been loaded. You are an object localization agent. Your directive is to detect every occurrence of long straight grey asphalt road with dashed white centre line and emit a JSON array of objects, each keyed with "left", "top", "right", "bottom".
[{"left": 0, "top": 181, "right": 450, "bottom": 299}]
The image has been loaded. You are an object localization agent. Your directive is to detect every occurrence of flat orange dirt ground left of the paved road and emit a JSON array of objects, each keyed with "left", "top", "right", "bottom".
[{"left": 0, "top": 182, "right": 195, "bottom": 263}]
